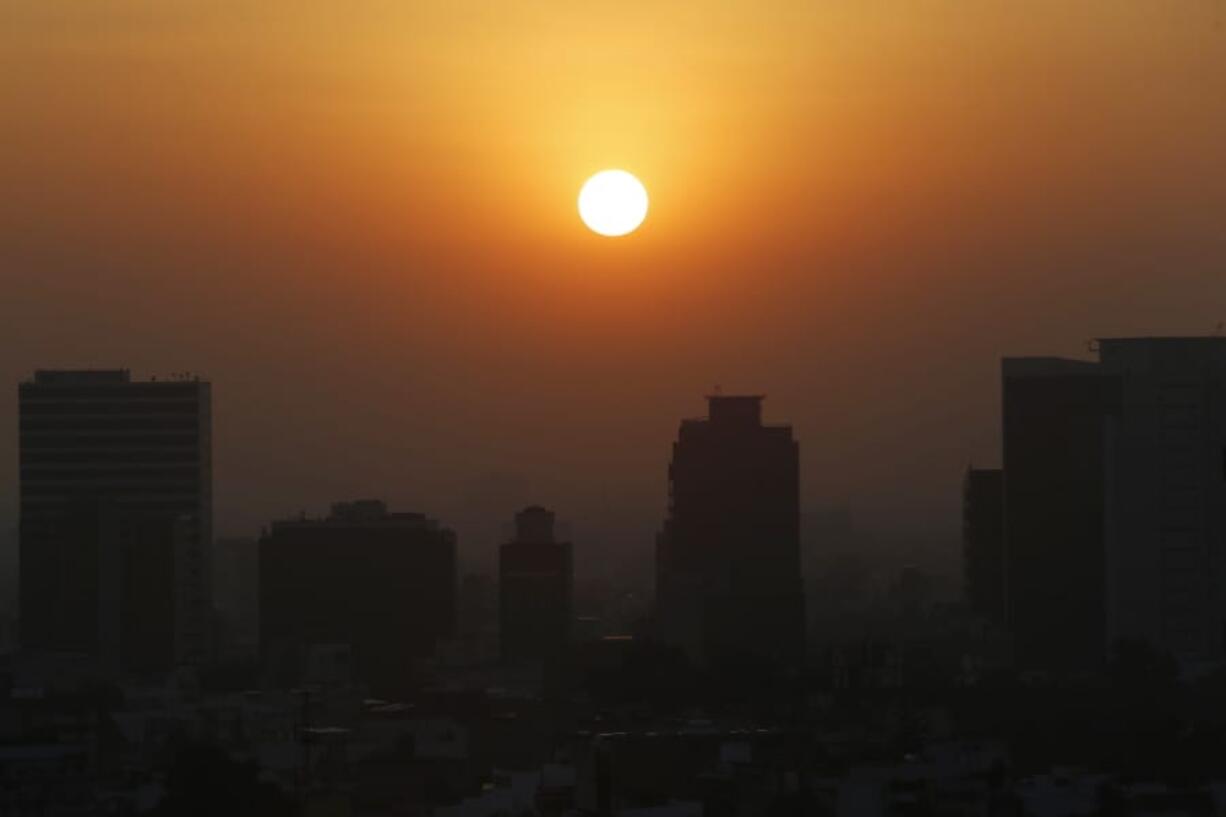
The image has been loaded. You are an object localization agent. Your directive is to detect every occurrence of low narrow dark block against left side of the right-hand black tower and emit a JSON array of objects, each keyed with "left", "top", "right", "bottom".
[{"left": 962, "top": 469, "right": 1004, "bottom": 626}]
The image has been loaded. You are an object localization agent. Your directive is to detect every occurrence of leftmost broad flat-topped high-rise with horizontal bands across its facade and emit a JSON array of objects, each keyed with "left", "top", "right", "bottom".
[{"left": 18, "top": 369, "right": 212, "bottom": 671}]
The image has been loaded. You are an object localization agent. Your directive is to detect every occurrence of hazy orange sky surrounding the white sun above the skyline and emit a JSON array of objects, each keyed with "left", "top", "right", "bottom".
[{"left": 0, "top": 0, "right": 1226, "bottom": 569}]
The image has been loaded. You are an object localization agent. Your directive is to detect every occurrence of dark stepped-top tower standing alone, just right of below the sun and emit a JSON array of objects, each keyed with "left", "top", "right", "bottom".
[{"left": 656, "top": 395, "right": 804, "bottom": 662}]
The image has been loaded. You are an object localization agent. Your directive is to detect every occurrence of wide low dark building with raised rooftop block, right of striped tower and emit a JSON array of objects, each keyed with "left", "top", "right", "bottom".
[{"left": 259, "top": 499, "right": 457, "bottom": 696}]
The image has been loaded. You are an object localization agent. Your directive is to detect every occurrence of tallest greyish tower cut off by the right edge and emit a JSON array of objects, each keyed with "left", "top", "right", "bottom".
[{"left": 1098, "top": 337, "right": 1226, "bottom": 666}]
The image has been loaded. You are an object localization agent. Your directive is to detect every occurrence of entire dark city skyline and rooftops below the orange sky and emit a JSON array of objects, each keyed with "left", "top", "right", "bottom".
[{"left": 7, "top": 337, "right": 1226, "bottom": 817}]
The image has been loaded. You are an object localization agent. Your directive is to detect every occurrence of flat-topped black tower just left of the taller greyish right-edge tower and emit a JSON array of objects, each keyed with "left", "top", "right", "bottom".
[{"left": 1003, "top": 358, "right": 1119, "bottom": 670}]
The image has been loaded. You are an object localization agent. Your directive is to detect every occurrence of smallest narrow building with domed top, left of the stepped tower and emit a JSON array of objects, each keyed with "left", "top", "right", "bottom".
[{"left": 498, "top": 505, "right": 574, "bottom": 661}]
